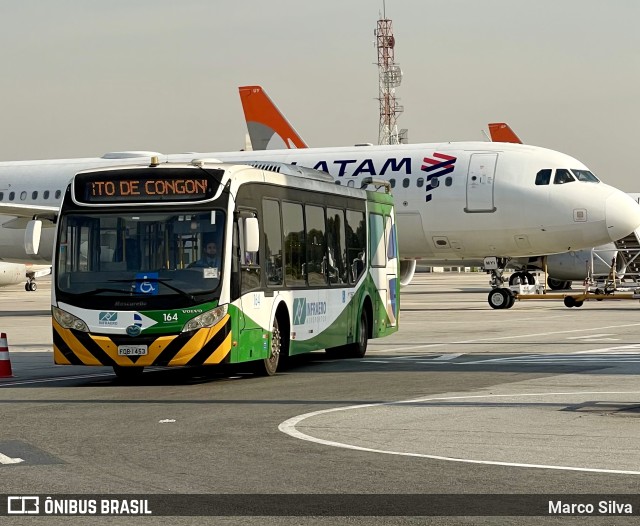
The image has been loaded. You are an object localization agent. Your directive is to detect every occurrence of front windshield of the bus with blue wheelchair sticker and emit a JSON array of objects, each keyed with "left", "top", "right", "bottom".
[{"left": 56, "top": 209, "right": 226, "bottom": 308}]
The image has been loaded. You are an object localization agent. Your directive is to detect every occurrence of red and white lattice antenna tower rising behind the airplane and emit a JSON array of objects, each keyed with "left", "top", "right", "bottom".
[{"left": 375, "top": 0, "right": 407, "bottom": 144}]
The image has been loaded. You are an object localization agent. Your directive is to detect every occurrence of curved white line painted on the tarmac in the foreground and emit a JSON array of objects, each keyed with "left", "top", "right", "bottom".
[{"left": 278, "top": 391, "right": 640, "bottom": 475}]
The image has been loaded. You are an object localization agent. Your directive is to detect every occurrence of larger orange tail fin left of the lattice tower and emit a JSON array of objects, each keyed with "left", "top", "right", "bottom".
[{"left": 238, "top": 86, "right": 308, "bottom": 150}]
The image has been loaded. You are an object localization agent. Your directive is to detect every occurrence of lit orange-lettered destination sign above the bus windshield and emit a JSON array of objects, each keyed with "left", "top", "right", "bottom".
[{"left": 74, "top": 168, "right": 223, "bottom": 204}]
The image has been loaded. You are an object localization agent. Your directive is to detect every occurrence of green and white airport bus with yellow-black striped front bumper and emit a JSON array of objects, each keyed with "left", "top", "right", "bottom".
[{"left": 42, "top": 158, "right": 400, "bottom": 378}]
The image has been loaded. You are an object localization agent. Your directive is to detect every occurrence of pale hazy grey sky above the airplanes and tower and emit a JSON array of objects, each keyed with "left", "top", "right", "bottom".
[{"left": 0, "top": 0, "right": 640, "bottom": 192}]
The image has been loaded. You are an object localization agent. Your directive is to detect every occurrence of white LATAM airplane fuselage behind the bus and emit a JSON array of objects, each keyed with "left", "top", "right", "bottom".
[{"left": 0, "top": 142, "right": 640, "bottom": 270}]
